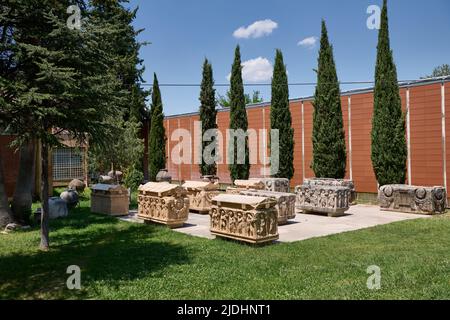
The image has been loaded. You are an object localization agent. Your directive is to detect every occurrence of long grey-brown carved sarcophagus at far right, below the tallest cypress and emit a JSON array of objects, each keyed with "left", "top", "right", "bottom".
[{"left": 378, "top": 184, "right": 447, "bottom": 214}]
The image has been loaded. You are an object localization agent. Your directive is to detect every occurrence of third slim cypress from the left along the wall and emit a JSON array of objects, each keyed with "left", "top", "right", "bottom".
[{"left": 228, "top": 46, "right": 250, "bottom": 181}]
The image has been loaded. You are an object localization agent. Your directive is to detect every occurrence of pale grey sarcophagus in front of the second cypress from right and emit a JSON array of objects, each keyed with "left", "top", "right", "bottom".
[{"left": 295, "top": 184, "right": 350, "bottom": 217}]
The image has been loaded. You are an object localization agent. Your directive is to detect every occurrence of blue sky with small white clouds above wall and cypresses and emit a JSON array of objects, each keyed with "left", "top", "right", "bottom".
[{"left": 125, "top": 0, "right": 450, "bottom": 115}]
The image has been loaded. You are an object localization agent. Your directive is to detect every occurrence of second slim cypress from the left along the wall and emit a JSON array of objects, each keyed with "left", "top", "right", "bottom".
[{"left": 199, "top": 59, "right": 217, "bottom": 176}]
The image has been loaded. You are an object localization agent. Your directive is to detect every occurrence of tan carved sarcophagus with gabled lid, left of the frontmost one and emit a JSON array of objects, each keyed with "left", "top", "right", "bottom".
[{"left": 138, "top": 182, "right": 189, "bottom": 228}]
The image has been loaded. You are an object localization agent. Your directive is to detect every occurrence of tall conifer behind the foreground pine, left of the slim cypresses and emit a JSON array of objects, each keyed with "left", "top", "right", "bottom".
[{"left": 85, "top": 1, "right": 148, "bottom": 189}]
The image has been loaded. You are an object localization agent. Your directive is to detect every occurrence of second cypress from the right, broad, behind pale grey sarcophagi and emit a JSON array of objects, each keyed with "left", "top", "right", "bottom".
[{"left": 311, "top": 21, "right": 347, "bottom": 179}]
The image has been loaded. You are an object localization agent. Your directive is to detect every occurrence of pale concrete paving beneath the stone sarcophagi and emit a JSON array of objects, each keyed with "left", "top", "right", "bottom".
[{"left": 121, "top": 205, "right": 430, "bottom": 242}]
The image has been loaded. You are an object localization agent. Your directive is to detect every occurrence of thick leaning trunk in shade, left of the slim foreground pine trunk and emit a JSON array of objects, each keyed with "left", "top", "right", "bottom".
[{"left": 11, "top": 141, "right": 35, "bottom": 224}]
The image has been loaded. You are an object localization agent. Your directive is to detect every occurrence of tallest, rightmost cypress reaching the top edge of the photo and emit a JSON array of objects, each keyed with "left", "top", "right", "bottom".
[{"left": 371, "top": 0, "right": 407, "bottom": 186}]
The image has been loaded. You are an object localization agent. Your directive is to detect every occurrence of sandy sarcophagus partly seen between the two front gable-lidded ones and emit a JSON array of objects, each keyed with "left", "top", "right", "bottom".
[{"left": 183, "top": 181, "right": 219, "bottom": 214}]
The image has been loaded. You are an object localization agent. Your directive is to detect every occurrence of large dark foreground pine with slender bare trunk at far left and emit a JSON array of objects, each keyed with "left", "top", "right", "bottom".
[{"left": 0, "top": 0, "right": 132, "bottom": 250}]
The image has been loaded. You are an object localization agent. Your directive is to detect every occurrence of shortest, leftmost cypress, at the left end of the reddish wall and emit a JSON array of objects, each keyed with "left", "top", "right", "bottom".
[{"left": 148, "top": 73, "right": 166, "bottom": 181}]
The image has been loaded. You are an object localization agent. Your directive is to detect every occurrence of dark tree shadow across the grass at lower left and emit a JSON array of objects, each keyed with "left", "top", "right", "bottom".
[{"left": 0, "top": 219, "right": 190, "bottom": 299}]
